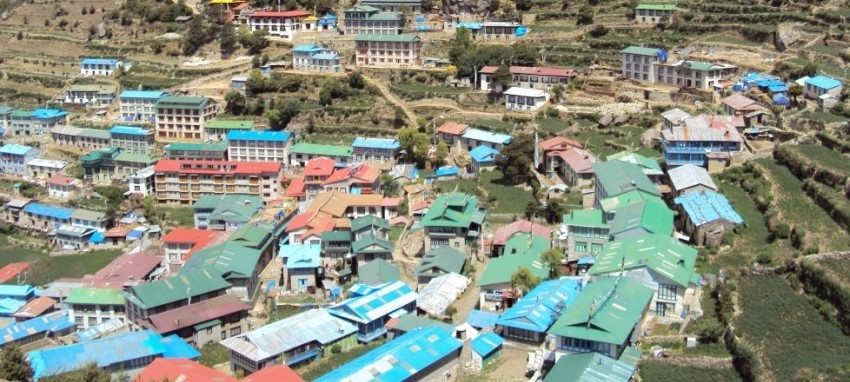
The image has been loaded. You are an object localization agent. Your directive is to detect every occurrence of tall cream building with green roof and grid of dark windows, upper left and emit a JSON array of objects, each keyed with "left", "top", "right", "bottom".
[{"left": 154, "top": 96, "right": 218, "bottom": 142}]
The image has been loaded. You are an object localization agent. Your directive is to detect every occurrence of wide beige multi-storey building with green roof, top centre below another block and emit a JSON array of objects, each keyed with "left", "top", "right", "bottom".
[{"left": 354, "top": 34, "right": 422, "bottom": 67}]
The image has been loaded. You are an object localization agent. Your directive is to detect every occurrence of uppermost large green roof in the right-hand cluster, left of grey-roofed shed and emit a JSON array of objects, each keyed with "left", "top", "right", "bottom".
[{"left": 592, "top": 160, "right": 661, "bottom": 198}]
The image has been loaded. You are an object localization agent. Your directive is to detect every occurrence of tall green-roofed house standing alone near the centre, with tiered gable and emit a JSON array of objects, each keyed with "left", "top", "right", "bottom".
[{"left": 421, "top": 192, "right": 486, "bottom": 252}]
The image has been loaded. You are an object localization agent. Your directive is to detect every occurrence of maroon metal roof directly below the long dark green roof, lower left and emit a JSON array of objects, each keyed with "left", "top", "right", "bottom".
[{"left": 142, "top": 294, "right": 250, "bottom": 334}]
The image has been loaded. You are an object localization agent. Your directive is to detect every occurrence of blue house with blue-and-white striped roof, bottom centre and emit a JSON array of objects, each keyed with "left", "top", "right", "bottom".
[{"left": 328, "top": 281, "right": 418, "bottom": 342}]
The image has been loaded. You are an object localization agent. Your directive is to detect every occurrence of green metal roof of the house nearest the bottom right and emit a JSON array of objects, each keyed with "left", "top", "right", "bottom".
[{"left": 548, "top": 277, "right": 653, "bottom": 345}]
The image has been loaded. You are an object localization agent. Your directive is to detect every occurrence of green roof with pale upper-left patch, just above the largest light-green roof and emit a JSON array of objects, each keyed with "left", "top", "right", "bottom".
[{"left": 599, "top": 190, "right": 675, "bottom": 236}]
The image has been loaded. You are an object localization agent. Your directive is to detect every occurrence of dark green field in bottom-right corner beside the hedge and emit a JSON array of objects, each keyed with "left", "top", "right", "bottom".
[{"left": 735, "top": 276, "right": 850, "bottom": 381}]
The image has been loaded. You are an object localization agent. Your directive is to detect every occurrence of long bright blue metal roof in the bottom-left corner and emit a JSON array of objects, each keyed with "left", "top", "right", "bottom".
[{"left": 27, "top": 330, "right": 200, "bottom": 380}]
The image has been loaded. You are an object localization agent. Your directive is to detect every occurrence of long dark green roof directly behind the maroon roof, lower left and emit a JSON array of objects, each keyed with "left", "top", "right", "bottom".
[{"left": 121, "top": 269, "right": 230, "bottom": 308}]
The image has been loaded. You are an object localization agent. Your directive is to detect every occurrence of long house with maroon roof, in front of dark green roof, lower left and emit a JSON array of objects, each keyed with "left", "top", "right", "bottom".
[{"left": 138, "top": 294, "right": 250, "bottom": 349}]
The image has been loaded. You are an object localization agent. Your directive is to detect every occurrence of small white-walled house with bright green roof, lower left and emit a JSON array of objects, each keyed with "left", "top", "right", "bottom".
[{"left": 63, "top": 288, "right": 126, "bottom": 330}]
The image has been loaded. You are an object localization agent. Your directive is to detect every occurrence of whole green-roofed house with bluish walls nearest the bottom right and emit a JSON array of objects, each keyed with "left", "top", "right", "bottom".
[{"left": 548, "top": 277, "right": 653, "bottom": 358}]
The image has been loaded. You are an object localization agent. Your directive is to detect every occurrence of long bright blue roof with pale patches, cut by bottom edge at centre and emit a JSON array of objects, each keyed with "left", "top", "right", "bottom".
[{"left": 316, "top": 327, "right": 463, "bottom": 382}]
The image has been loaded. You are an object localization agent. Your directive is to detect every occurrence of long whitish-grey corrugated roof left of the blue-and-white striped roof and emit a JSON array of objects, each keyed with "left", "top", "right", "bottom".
[{"left": 221, "top": 309, "right": 357, "bottom": 361}]
